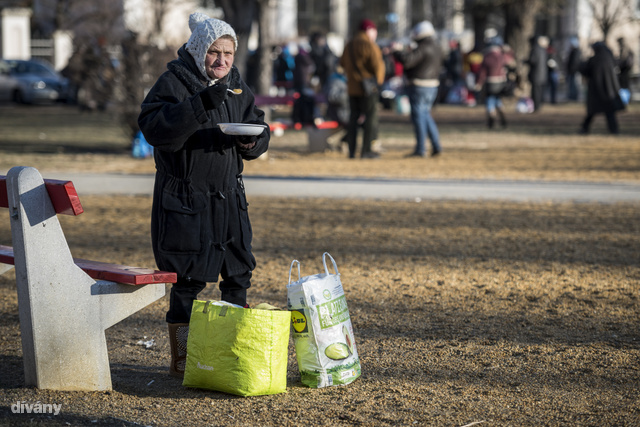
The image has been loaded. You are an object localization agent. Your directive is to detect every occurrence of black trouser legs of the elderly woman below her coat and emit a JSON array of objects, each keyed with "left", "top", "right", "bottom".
[{"left": 166, "top": 264, "right": 251, "bottom": 323}]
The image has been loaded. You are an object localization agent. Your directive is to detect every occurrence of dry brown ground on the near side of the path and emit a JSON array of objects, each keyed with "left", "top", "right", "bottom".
[{"left": 0, "top": 197, "right": 640, "bottom": 426}]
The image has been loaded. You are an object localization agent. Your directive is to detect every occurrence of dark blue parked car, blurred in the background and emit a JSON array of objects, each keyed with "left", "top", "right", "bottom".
[{"left": 0, "top": 59, "right": 69, "bottom": 104}]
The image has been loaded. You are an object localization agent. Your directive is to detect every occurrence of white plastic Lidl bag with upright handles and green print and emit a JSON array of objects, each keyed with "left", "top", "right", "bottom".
[{"left": 287, "top": 252, "right": 361, "bottom": 388}]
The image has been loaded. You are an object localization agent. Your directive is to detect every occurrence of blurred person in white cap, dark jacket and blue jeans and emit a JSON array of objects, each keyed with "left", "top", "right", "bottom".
[{"left": 394, "top": 21, "right": 442, "bottom": 157}]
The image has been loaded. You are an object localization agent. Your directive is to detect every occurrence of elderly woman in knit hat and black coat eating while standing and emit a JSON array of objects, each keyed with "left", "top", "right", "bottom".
[{"left": 138, "top": 13, "right": 270, "bottom": 376}]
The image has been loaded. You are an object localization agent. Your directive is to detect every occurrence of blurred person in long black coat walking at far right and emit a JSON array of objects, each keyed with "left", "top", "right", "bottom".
[{"left": 580, "top": 42, "right": 624, "bottom": 134}]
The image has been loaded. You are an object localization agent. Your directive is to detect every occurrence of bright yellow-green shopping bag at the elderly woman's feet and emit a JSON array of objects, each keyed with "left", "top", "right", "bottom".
[{"left": 182, "top": 300, "right": 291, "bottom": 396}]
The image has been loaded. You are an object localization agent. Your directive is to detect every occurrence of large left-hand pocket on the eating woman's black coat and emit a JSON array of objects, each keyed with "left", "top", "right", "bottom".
[{"left": 159, "top": 191, "right": 208, "bottom": 253}]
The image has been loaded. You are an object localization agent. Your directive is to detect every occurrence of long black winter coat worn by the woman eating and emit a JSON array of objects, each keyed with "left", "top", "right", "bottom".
[{"left": 138, "top": 46, "right": 270, "bottom": 282}]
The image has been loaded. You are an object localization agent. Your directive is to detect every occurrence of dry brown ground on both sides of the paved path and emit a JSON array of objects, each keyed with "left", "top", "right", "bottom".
[{"left": 0, "top": 105, "right": 640, "bottom": 426}]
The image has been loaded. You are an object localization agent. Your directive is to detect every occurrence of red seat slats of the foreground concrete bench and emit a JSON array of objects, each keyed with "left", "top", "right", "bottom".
[{"left": 0, "top": 245, "right": 178, "bottom": 285}]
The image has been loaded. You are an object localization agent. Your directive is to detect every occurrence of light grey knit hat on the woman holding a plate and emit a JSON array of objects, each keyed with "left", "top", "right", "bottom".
[{"left": 186, "top": 12, "right": 238, "bottom": 80}]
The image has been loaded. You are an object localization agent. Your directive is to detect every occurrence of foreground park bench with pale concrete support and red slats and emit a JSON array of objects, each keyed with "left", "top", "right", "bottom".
[{"left": 0, "top": 166, "right": 177, "bottom": 390}]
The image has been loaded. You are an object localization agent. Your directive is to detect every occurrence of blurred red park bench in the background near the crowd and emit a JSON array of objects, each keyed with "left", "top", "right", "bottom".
[{"left": 255, "top": 94, "right": 342, "bottom": 153}]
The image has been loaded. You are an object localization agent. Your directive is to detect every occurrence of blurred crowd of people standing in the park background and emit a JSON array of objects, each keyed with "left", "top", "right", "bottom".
[{"left": 264, "top": 19, "right": 634, "bottom": 158}]
